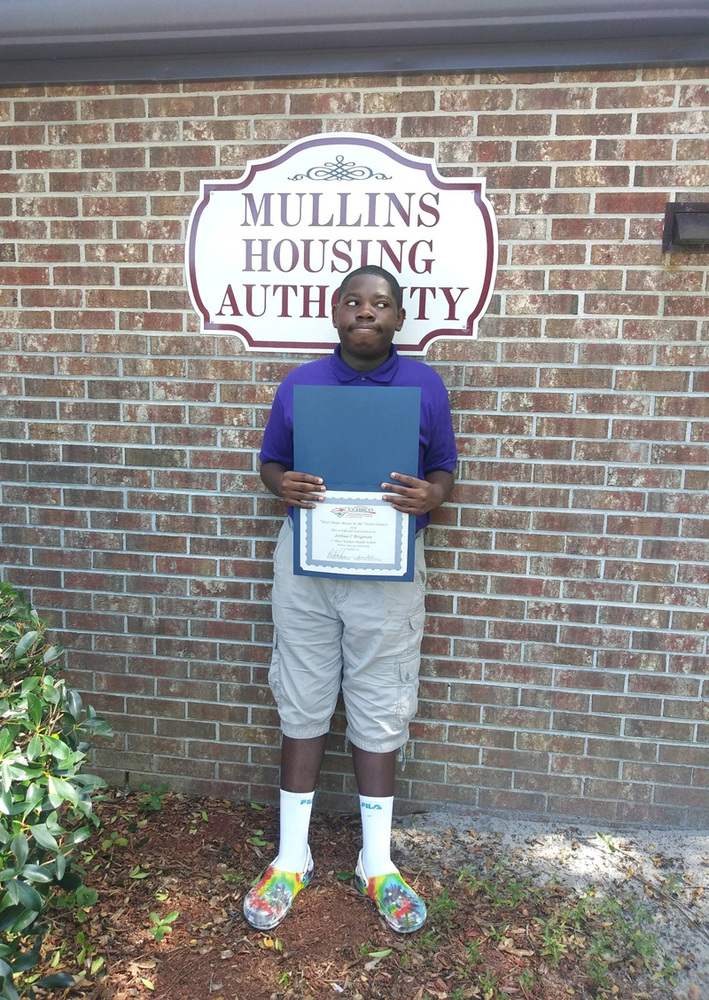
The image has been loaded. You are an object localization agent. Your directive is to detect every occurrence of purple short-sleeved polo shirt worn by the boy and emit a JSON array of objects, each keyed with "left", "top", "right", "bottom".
[{"left": 259, "top": 344, "right": 458, "bottom": 531}]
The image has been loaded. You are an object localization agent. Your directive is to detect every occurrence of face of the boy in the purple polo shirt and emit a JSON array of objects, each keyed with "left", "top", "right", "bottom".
[{"left": 332, "top": 274, "right": 406, "bottom": 371}]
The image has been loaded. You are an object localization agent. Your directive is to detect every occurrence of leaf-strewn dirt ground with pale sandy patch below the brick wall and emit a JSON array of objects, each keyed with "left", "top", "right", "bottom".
[{"left": 35, "top": 792, "right": 709, "bottom": 1000}]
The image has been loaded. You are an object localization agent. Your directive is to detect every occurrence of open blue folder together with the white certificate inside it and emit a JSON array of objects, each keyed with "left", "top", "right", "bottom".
[{"left": 293, "top": 385, "right": 421, "bottom": 581}]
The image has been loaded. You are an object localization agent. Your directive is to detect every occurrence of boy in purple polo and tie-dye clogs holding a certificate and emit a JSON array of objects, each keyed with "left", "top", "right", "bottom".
[{"left": 244, "top": 266, "right": 457, "bottom": 933}]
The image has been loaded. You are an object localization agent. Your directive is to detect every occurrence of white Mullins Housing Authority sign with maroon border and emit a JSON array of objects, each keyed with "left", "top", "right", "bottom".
[{"left": 186, "top": 132, "right": 497, "bottom": 355}]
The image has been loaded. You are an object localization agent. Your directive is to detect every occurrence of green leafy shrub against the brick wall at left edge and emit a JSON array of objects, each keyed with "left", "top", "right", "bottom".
[{"left": 0, "top": 583, "right": 111, "bottom": 1000}]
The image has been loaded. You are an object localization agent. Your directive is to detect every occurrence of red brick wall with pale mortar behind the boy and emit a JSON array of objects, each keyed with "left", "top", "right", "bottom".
[{"left": 0, "top": 68, "right": 709, "bottom": 825}]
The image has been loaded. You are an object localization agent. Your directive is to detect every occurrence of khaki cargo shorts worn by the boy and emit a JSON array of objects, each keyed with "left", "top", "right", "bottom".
[{"left": 268, "top": 518, "right": 426, "bottom": 753}]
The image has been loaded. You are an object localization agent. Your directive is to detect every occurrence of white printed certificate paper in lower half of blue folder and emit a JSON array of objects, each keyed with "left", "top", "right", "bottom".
[{"left": 298, "top": 490, "right": 411, "bottom": 580}]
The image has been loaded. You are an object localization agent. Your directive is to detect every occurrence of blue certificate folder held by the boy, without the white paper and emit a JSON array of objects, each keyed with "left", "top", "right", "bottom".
[{"left": 293, "top": 385, "right": 421, "bottom": 581}]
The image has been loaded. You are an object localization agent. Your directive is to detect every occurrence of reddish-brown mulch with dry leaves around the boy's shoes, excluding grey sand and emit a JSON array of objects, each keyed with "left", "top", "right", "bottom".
[{"left": 27, "top": 793, "right": 670, "bottom": 1000}]
